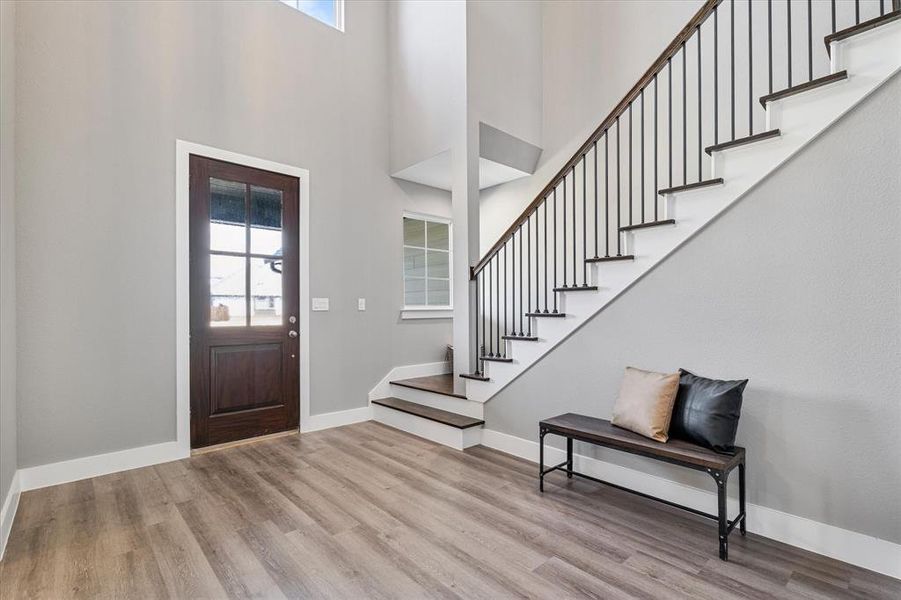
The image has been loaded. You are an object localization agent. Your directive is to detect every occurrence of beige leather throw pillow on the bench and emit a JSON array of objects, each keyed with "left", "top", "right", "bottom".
[{"left": 612, "top": 367, "right": 679, "bottom": 442}]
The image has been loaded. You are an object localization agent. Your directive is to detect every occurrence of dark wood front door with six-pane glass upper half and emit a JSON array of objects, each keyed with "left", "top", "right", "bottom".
[{"left": 190, "top": 155, "right": 306, "bottom": 448}]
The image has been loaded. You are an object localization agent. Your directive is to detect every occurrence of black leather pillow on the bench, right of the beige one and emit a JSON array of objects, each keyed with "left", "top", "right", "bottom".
[{"left": 669, "top": 369, "right": 748, "bottom": 454}]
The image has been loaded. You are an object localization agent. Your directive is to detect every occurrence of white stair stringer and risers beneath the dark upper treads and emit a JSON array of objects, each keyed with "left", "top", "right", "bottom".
[{"left": 466, "top": 21, "right": 901, "bottom": 403}]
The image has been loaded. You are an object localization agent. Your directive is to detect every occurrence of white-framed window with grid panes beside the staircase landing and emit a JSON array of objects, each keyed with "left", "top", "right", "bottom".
[{"left": 404, "top": 213, "right": 453, "bottom": 309}]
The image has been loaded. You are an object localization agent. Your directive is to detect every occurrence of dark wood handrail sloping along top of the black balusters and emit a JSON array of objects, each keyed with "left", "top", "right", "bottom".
[{"left": 470, "top": 0, "right": 722, "bottom": 279}]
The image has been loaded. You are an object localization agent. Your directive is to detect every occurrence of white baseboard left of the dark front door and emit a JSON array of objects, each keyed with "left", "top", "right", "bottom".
[{"left": 18, "top": 441, "right": 190, "bottom": 492}]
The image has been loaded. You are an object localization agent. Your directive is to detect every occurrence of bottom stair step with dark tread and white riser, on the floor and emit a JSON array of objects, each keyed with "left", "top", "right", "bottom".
[{"left": 371, "top": 397, "right": 485, "bottom": 450}]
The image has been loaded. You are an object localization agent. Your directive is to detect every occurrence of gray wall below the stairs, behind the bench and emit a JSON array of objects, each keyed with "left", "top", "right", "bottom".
[{"left": 486, "top": 75, "right": 901, "bottom": 542}]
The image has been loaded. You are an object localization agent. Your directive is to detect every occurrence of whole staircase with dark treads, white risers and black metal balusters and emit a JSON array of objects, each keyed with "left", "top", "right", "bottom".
[{"left": 370, "top": 0, "right": 901, "bottom": 449}]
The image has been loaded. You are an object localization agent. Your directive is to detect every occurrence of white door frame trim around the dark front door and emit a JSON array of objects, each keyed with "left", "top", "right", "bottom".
[{"left": 175, "top": 139, "right": 310, "bottom": 456}]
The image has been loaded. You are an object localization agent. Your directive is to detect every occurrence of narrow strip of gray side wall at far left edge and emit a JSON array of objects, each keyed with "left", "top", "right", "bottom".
[{"left": 0, "top": 2, "right": 16, "bottom": 504}]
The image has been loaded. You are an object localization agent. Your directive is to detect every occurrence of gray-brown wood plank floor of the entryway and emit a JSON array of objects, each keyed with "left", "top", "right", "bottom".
[{"left": 0, "top": 422, "right": 901, "bottom": 600}]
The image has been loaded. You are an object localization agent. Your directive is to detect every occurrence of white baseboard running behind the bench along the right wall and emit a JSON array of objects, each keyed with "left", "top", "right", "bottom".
[{"left": 482, "top": 429, "right": 901, "bottom": 579}]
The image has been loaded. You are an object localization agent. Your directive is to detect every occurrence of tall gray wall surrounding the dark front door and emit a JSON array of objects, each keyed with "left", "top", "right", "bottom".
[{"left": 14, "top": 2, "right": 451, "bottom": 467}]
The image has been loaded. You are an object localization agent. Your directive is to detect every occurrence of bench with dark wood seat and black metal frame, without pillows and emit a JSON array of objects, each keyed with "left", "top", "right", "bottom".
[{"left": 538, "top": 425, "right": 747, "bottom": 560}]
